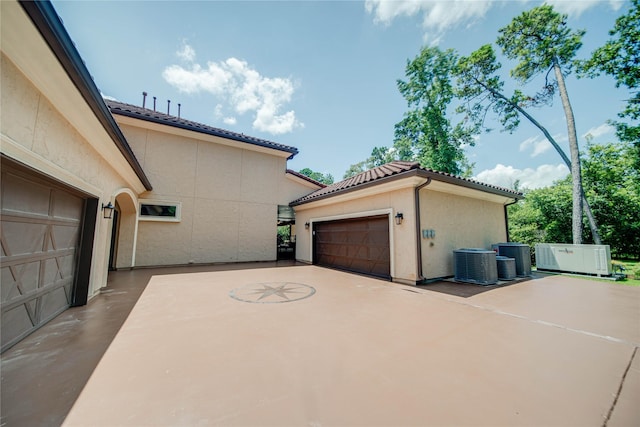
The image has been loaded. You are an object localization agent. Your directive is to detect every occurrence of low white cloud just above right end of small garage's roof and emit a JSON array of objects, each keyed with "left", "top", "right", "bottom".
[{"left": 474, "top": 164, "right": 569, "bottom": 189}]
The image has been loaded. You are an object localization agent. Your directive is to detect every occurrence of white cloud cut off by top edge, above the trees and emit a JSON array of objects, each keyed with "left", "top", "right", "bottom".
[{"left": 364, "top": 0, "right": 494, "bottom": 45}]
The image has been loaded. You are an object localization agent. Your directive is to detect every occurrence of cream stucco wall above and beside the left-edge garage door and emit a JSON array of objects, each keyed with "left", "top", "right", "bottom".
[{"left": 0, "top": 54, "right": 136, "bottom": 297}]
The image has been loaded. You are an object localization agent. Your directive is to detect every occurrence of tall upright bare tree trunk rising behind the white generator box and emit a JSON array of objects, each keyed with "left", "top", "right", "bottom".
[{"left": 553, "top": 61, "right": 583, "bottom": 245}]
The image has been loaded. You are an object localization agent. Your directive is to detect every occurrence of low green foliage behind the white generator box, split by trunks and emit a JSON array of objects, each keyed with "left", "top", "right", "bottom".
[{"left": 509, "top": 143, "right": 640, "bottom": 259}]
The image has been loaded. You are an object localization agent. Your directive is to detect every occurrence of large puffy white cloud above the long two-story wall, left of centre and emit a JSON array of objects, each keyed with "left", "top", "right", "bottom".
[{"left": 162, "top": 44, "right": 304, "bottom": 134}]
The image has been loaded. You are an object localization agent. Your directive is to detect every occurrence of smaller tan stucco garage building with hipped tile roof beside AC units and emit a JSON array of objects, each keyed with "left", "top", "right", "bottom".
[{"left": 291, "top": 162, "right": 522, "bottom": 285}]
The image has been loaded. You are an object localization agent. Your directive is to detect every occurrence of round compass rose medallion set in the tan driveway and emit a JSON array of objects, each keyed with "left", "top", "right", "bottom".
[{"left": 229, "top": 282, "right": 316, "bottom": 304}]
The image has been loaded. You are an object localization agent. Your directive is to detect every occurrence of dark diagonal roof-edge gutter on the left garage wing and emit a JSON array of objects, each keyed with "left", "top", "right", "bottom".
[{"left": 19, "top": 0, "right": 153, "bottom": 191}]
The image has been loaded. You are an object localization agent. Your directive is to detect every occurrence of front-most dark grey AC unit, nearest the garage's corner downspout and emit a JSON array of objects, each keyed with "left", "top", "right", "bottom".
[{"left": 453, "top": 248, "right": 498, "bottom": 285}]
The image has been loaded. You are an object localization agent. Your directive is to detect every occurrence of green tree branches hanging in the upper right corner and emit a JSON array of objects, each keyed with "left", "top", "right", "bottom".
[{"left": 580, "top": 0, "right": 640, "bottom": 153}]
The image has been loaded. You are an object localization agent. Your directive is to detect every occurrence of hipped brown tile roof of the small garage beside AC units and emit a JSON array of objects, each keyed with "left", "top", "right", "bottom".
[{"left": 290, "top": 161, "right": 522, "bottom": 206}]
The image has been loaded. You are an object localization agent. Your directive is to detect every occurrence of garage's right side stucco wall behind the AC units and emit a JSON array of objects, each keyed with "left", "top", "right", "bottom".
[{"left": 420, "top": 187, "right": 507, "bottom": 279}]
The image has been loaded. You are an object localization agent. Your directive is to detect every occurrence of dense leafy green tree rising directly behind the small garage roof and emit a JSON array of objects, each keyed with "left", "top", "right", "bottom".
[{"left": 394, "top": 47, "right": 476, "bottom": 175}]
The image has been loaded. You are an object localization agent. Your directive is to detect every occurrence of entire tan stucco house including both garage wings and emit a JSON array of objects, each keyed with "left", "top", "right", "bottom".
[{"left": 0, "top": 0, "right": 521, "bottom": 351}]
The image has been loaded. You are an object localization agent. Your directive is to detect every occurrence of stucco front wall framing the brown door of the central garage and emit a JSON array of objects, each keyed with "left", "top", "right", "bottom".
[{"left": 294, "top": 188, "right": 418, "bottom": 284}]
